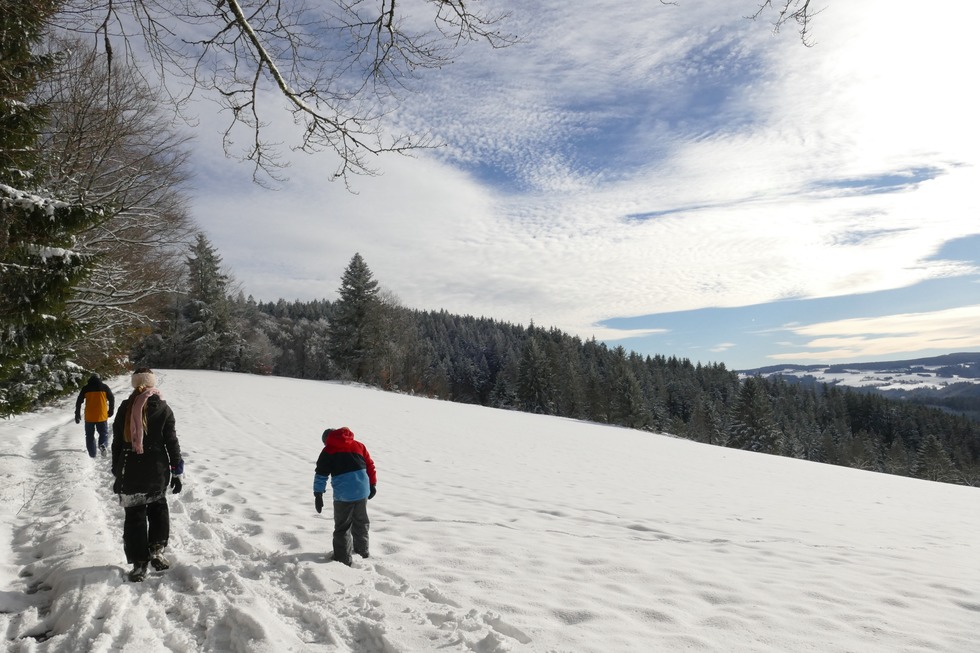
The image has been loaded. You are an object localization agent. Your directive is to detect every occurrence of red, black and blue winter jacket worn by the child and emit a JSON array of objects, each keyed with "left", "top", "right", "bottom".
[{"left": 313, "top": 426, "right": 378, "bottom": 501}]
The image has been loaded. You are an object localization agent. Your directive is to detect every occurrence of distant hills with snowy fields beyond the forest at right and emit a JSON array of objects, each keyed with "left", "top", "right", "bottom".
[{"left": 739, "top": 352, "right": 980, "bottom": 420}]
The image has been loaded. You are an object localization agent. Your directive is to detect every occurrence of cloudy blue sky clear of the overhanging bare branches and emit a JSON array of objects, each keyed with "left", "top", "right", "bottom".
[{"left": 186, "top": 0, "right": 980, "bottom": 369}]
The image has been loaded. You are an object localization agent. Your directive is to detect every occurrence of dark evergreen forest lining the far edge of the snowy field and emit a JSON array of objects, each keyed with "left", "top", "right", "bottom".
[{"left": 133, "top": 247, "right": 980, "bottom": 485}]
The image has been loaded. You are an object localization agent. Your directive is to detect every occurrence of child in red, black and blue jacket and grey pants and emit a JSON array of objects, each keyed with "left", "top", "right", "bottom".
[{"left": 313, "top": 426, "right": 378, "bottom": 566}]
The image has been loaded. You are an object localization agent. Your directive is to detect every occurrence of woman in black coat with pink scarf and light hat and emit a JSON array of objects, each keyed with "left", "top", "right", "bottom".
[{"left": 112, "top": 368, "right": 184, "bottom": 581}]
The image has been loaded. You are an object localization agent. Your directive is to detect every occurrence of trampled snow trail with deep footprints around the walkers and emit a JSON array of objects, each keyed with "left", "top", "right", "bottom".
[{"left": 2, "top": 376, "right": 530, "bottom": 653}]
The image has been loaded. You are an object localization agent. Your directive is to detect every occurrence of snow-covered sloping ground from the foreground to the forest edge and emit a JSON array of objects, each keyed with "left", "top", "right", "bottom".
[{"left": 0, "top": 370, "right": 980, "bottom": 653}]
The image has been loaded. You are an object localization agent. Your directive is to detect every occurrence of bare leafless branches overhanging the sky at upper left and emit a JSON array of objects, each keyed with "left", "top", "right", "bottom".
[{"left": 50, "top": 0, "right": 515, "bottom": 183}]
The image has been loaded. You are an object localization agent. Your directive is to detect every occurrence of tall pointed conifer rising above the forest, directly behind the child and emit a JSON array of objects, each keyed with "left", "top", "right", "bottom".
[{"left": 330, "top": 253, "right": 381, "bottom": 381}]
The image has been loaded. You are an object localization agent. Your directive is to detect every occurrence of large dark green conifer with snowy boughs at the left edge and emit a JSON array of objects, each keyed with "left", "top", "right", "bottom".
[{"left": 0, "top": 0, "right": 103, "bottom": 416}]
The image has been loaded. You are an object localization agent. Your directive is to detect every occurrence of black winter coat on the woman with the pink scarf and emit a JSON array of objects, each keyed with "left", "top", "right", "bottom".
[{"left": 112, "top": 393, "right": 181, "bottom": 495}]
